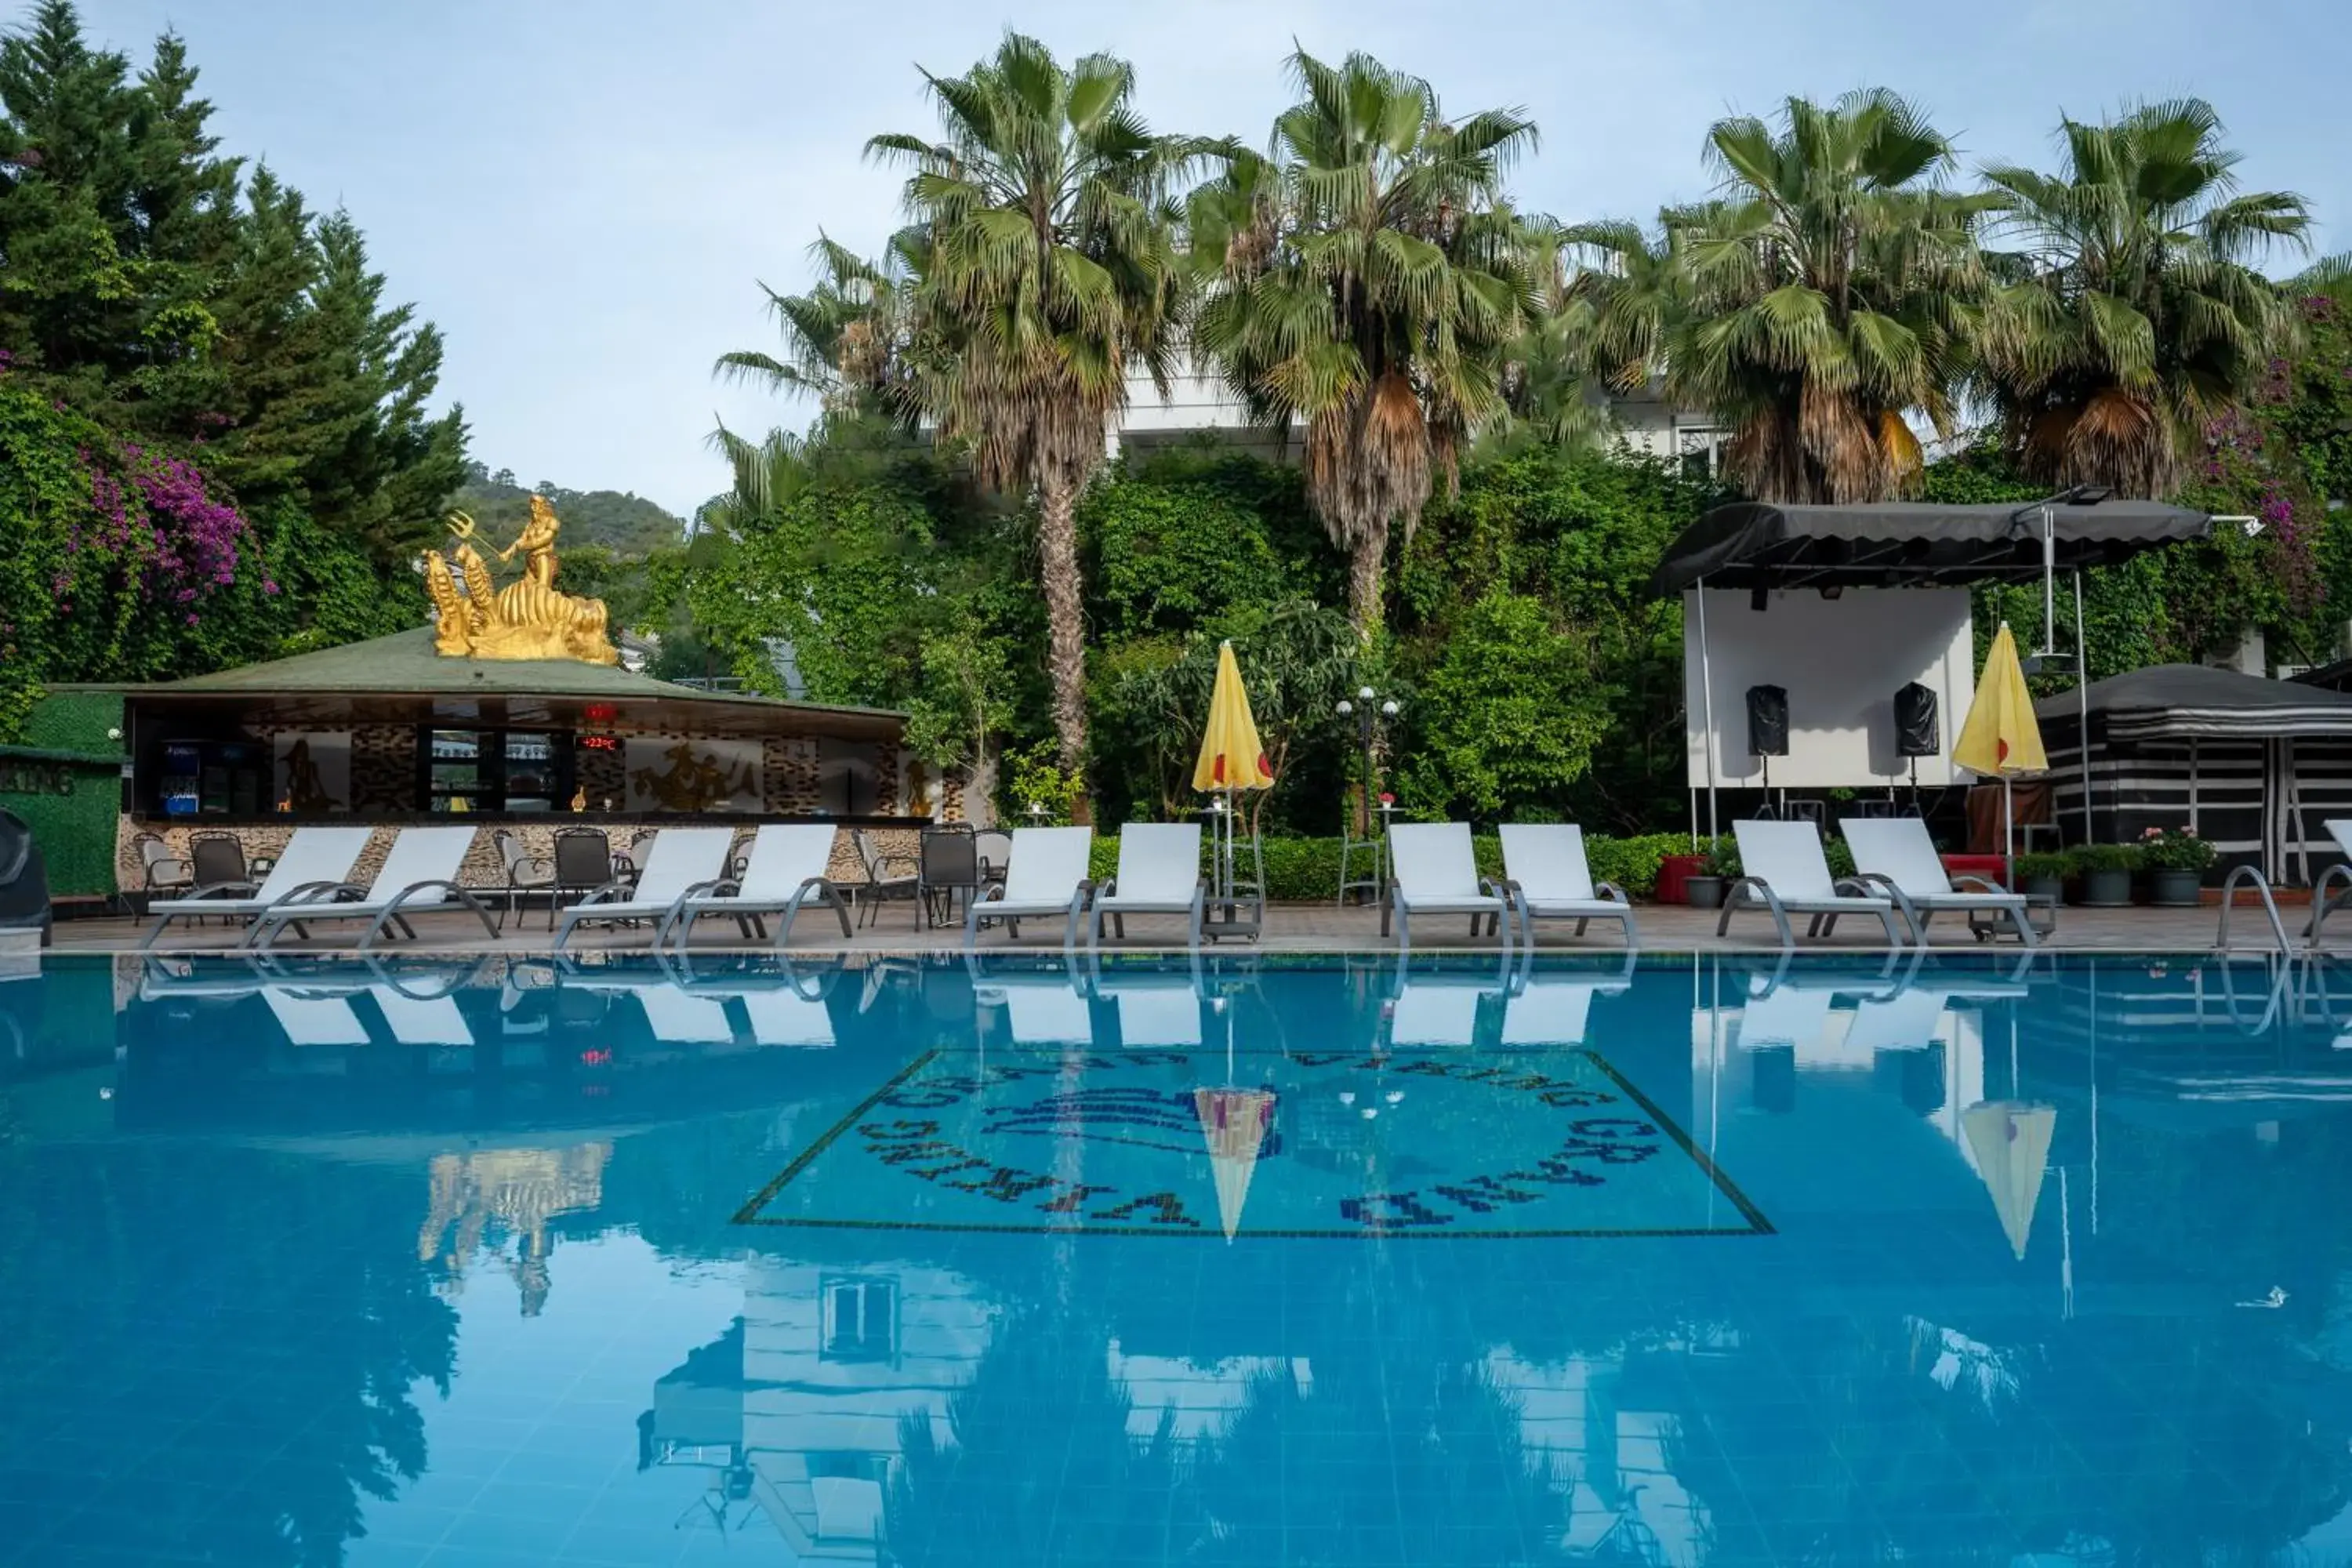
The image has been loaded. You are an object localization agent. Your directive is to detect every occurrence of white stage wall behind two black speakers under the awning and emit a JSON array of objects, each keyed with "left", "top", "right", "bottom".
[{"left": 1682, "top": 588, "right": 1976, "bottom": 789}]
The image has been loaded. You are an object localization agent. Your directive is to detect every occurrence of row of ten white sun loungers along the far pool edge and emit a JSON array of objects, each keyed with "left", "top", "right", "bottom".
[{"left": 129, "top": 818, "right": 2034, "bottom": 952}]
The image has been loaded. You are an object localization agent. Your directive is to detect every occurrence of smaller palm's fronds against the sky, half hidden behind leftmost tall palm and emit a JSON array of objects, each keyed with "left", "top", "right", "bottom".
[{"left": 713, "top": 230, "right": 927, "bottom": 419}]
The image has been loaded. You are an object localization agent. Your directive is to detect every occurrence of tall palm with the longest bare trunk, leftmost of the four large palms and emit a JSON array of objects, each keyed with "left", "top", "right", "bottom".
[{"left": 866, "top": 33, "right": 1207, "bottom": 801}]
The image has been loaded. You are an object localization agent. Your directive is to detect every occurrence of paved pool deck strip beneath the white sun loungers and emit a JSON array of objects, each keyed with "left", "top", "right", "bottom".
[{"left": 54, "top": 902, "right": 2305, "bottom": 954}]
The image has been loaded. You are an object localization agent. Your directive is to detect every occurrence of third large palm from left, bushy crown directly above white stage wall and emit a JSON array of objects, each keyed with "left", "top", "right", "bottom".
[{"left": 1663, "top": 89, "right": 1987, "bottom": 501}]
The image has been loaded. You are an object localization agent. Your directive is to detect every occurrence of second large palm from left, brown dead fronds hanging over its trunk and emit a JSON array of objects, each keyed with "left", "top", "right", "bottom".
[{"left": 1190, "top": 52, "right": 1536, "bottom": 637}]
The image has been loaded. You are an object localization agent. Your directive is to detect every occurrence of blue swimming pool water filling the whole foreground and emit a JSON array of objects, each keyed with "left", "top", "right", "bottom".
[{"left": 0, "top": 954, "right": 2352, "bottom": 1568}]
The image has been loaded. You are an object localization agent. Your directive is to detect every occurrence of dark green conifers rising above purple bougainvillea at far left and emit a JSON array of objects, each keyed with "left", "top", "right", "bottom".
[{"left": 0, "top": 0, "right": 466, "bottom": 564}]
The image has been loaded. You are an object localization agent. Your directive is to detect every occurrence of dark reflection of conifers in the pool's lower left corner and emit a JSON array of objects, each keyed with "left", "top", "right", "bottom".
[{"left": 0, "top": 1142, "right": 456, "bottom": 1568}]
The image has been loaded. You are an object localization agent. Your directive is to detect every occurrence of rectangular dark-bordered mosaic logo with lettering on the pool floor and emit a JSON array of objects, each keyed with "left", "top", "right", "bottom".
[{"left": 736, "top": 1051, "right": 1771, "bottom": 1239}]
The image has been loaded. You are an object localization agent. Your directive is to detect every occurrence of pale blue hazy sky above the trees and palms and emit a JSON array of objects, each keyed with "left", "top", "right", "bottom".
[{"left": 68, "top": 0, "right": 2352, "bottom": 513}]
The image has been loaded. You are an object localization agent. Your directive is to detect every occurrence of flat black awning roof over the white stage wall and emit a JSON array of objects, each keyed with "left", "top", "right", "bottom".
[{"left": 1651, "top": 501, "right": 2213, "bottom": 595}]
